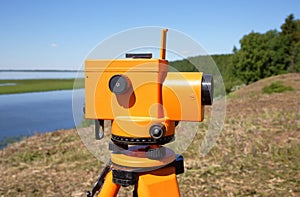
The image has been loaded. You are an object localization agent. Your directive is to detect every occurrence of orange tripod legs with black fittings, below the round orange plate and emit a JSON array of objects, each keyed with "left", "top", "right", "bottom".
[{"left": 88, "top": 155, "right": 184, "bottom": 197}]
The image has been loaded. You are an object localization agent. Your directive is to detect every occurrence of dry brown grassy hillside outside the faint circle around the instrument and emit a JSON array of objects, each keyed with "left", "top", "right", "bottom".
[{"left": 0, "top": 74, "right": 300, "bottom": 196}]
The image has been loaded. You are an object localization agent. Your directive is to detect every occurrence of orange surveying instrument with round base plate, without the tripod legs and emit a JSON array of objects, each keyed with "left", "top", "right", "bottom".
[{"left": 85, "top": 29, "right": 213, "bottom": 167}]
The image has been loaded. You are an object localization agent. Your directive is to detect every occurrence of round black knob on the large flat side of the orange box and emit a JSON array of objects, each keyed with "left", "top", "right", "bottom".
[{"left": 108, "top": 75, "right": 131, "bottom": 94}]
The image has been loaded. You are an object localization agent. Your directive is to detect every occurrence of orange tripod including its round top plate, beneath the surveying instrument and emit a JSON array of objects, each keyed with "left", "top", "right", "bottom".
[{"left": 86, "top": 143, "right": 184, "bottom": 197}]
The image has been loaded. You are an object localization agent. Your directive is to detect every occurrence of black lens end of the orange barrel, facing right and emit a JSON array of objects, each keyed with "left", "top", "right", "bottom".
[{"left": 201, "top": 74, "right": 214, "bottom": 105}]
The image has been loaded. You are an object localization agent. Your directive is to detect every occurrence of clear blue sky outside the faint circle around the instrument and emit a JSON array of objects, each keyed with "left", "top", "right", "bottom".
[{"left": 0, "top": 0, "right": 300, "bottom": 70}]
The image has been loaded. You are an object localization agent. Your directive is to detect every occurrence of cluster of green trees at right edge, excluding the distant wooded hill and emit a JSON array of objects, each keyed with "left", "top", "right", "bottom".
[{"left": 233, "top": 14, "right": 300, "bottom": 84}]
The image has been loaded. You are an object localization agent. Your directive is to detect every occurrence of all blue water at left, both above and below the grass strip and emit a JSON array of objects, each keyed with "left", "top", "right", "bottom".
[{"left": 0, "top": 72, "right": 84, "bottom": 148}]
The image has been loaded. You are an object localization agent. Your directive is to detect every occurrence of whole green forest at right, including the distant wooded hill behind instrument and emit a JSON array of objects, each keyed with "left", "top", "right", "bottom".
[{"left": 170, "top": 14, "right": 300, "bottom": 93}]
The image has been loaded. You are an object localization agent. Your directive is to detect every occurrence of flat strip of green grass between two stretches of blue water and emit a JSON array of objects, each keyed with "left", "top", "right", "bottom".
[{"left": 0, "top": 79, "right": 84, "bottom": 94}]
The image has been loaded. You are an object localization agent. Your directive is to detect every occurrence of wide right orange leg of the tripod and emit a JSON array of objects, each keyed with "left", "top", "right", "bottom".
[{"left": 137, "top": 166, "right": 180, "bottom": 197}]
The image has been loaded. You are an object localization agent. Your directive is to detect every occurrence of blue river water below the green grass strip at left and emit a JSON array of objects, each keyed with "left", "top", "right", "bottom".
[{"left": 0, "top": 90, "right": 83, "bottom": 139}]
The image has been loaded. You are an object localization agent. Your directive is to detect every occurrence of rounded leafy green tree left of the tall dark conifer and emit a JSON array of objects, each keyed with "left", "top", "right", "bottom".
[{"left": 233, "top": 30, "right": 286, "bottom": 84}]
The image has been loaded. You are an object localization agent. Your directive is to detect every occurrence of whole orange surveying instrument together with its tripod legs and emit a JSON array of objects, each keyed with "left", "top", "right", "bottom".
[{"left": 85, "top": 29, "right": 213, "bottom": 197}]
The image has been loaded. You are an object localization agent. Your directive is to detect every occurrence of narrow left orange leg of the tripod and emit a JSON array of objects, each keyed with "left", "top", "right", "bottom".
[{"left": 98, "top": 171, "right": 120, "bottom": 197}]
